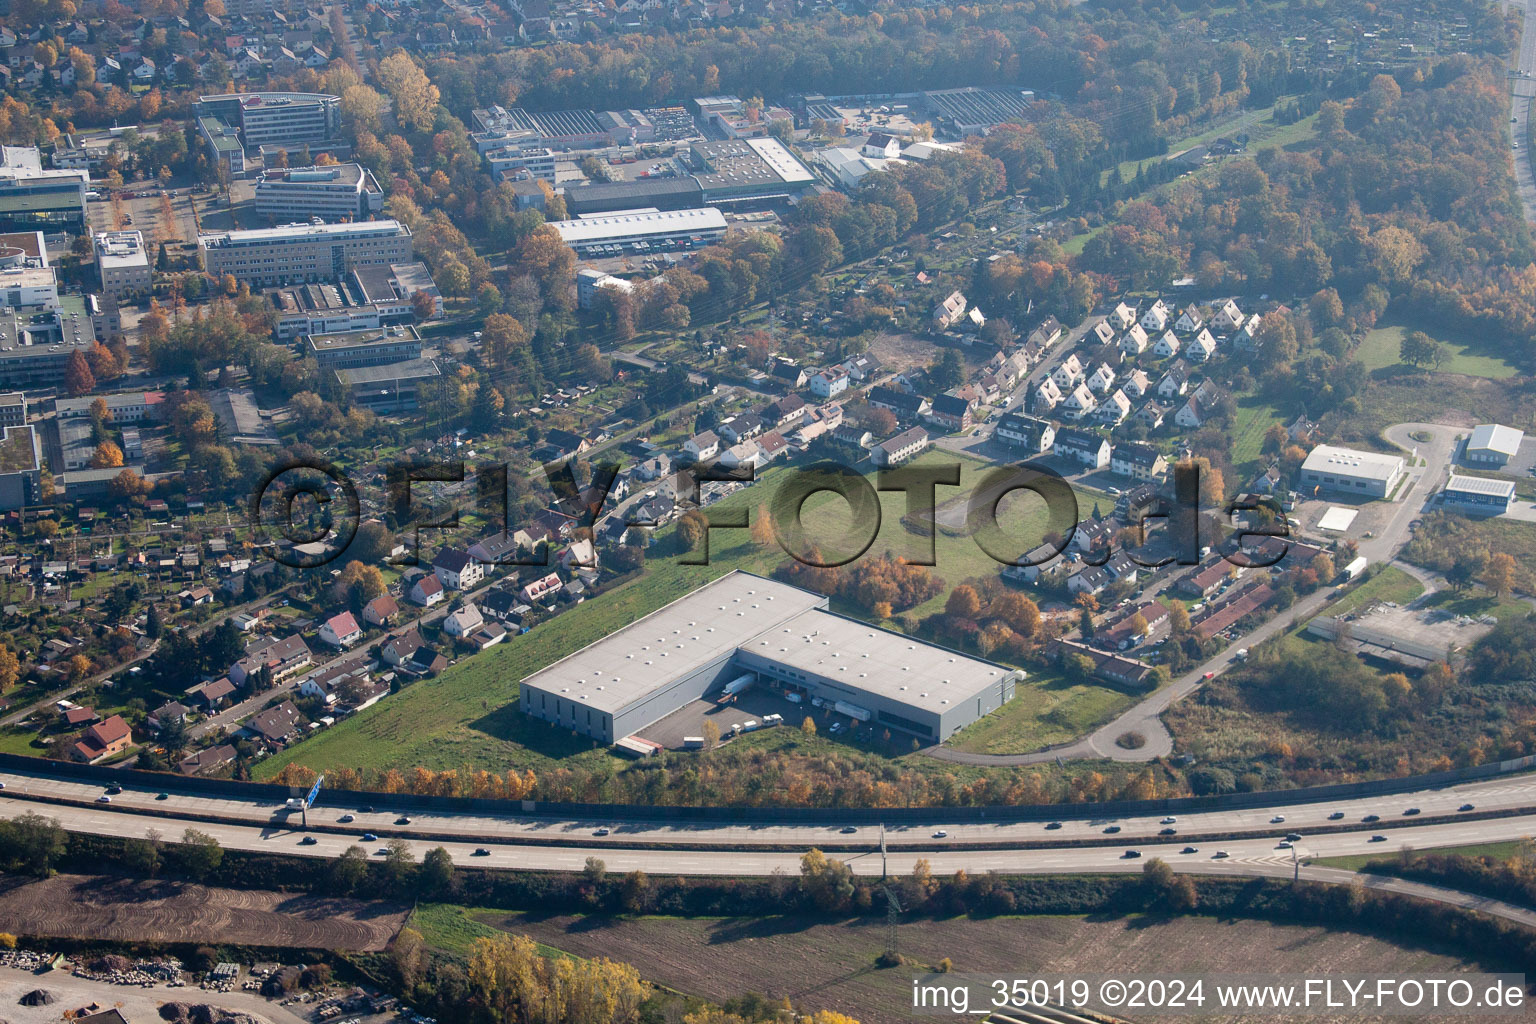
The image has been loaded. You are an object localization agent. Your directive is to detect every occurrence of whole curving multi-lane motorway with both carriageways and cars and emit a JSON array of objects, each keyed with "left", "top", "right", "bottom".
[{"left": 0, "top": 769, "right": 1536, "bottom": 875}]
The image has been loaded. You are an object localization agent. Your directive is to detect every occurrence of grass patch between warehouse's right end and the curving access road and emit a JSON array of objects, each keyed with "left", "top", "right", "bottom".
[{"left": 949, "top": 672, "right": 1135, "bottom": 754}]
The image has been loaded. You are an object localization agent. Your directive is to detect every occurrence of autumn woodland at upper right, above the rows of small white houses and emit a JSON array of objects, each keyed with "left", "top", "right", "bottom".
[{"left": 1083, "top": 55, "right": 1536, "bottom": 338}]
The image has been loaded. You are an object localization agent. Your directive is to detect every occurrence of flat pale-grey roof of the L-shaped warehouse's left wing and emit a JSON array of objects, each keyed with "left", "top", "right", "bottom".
[{"left": 522, "top": 571, "right": 826, "bottom": 714}]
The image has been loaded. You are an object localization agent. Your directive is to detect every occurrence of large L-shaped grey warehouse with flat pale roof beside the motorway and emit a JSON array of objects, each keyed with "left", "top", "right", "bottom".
[{"left": 521, "top": 571, "right": 1025, "bottom": 743}]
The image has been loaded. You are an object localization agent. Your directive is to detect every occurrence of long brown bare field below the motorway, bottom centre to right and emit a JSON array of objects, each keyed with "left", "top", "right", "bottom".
[{"left": 481, "top": 913, "right": 1468, "bottom": 1024}]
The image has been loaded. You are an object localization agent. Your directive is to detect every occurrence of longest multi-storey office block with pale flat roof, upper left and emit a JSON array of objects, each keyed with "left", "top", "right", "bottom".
[{"left": 198, "top": 221, "right": 413, "bottom": 286}]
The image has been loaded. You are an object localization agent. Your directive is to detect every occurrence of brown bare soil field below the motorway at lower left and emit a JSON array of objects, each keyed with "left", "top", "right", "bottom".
[{"left": 0, "top": 875, "right": 409, "bottom": 950}]
